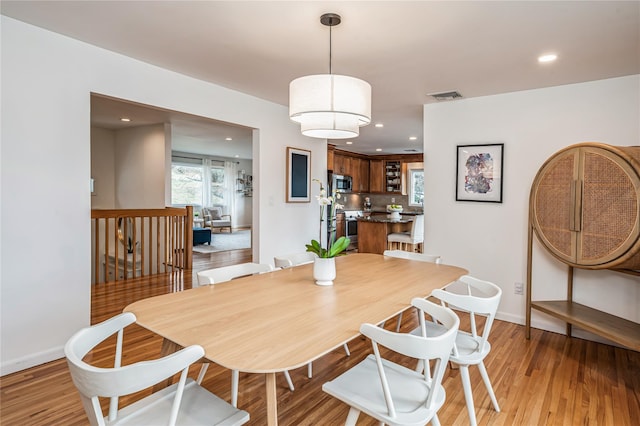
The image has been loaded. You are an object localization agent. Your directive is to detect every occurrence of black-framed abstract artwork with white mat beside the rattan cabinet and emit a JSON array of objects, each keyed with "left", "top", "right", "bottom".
[{"left": 456, "top": 143, "right": 504, "bottom": 203}]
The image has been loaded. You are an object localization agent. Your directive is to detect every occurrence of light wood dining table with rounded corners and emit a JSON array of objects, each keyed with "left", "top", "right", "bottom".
[{"left": 124, "top": 253, "right": 467, "bottom": 425}]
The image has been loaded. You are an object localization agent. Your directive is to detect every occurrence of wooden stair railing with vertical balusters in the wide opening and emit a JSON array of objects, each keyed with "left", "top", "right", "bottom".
[{"left": 91, "top": 206, "right": 193, "bottom": 283}]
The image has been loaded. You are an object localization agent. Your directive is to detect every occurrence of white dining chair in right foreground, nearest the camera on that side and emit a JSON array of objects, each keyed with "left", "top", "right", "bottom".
[{"left": 322, "top": 298, "right": 460, "bottom": 425}]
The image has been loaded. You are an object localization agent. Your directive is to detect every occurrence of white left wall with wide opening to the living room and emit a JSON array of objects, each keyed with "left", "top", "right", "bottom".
[{"left": 0, "top": 16, "right": 326, "bottom": 374}]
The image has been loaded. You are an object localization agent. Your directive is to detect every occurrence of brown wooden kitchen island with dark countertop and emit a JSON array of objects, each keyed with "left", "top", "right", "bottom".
[{"left": 358, "top": 214, "right": 411, "bottom": 254}]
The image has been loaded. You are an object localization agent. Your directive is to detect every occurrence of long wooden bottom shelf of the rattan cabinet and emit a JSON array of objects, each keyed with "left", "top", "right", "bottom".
[{"left": 531, "top": 300, "right": 640, "bottom": 351}]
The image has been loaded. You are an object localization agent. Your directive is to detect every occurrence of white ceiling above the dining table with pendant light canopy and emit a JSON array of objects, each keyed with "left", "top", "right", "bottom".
[{"left": 0, "top": 0, "right": 640, "bottom": 154}]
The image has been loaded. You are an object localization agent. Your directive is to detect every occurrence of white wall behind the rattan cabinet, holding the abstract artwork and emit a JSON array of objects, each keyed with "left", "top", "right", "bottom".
[{"left": 424, "top": 75, "right": 640, "bottom": 342}]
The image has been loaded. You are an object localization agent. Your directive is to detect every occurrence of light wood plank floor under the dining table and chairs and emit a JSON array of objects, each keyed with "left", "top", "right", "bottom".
[{"left": 0, "top": 250, "right": 640, "bottom": 426}]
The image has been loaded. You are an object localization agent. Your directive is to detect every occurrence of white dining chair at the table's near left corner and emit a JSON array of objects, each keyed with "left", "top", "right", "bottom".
[{"left": 64, "top": 312, "right": 249, "bottom": 425}]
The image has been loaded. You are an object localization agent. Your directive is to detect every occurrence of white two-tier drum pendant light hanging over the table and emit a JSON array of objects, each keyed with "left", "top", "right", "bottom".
[{"left": 289, "top": 13, "right": 371, "bottom": 139}]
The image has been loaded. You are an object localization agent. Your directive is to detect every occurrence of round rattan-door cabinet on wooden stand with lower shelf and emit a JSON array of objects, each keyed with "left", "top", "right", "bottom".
[{"left": 526, "top": 142, "right": 640, "bottom": 351}]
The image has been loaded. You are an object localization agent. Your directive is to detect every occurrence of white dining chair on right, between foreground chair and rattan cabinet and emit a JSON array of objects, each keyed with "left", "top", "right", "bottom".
[{"left": 411, "top": 275, "right": 502, "bottom": 425}]
